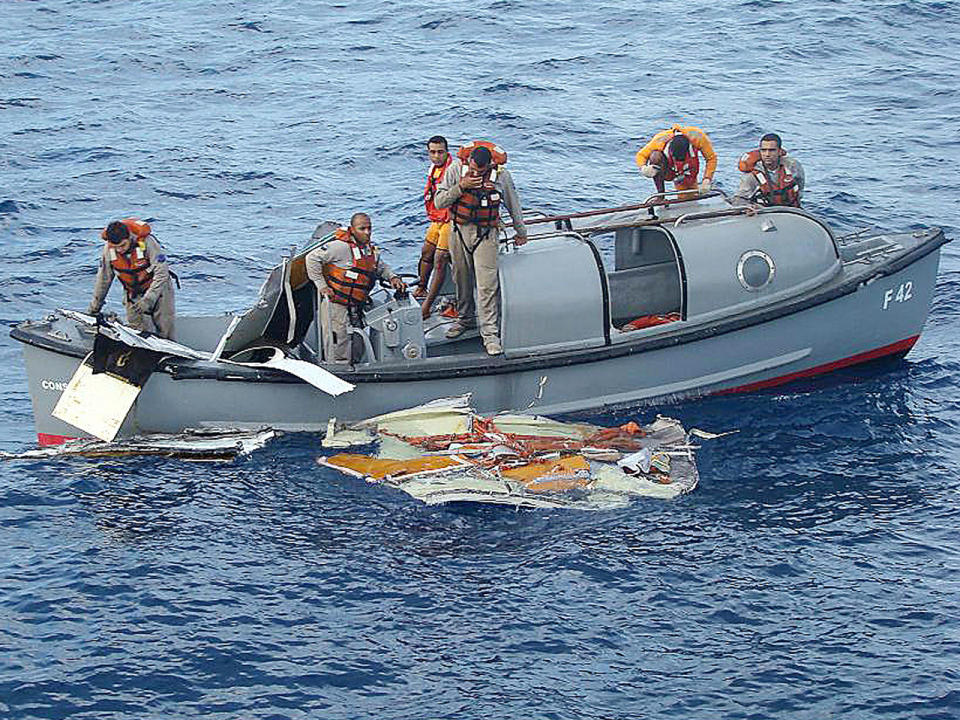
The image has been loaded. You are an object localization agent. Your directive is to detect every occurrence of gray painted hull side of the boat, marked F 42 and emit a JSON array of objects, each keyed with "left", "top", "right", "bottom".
[{"left": 16, "top": 248, "right": 939, "bottom": 443}]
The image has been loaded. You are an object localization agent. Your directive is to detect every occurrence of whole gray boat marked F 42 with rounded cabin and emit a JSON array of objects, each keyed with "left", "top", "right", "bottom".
[{"left": 11, "top": 192, "right": 947, "bottom": 444}]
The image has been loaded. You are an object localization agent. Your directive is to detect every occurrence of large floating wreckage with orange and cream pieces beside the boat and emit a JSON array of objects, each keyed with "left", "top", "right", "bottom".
[{"left": 317, "top": 395, "right": 724, "bottom": 509}]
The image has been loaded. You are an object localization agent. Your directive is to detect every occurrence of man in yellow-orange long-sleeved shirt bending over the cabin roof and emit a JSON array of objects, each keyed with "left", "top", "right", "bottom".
[{"left": 637, "top": 125, "right": 717, "bottom": 200}]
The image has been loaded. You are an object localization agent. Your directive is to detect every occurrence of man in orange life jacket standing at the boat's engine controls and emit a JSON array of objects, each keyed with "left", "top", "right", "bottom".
[{"left": 305, "top": 213, "right": 407, "bottom": 363}]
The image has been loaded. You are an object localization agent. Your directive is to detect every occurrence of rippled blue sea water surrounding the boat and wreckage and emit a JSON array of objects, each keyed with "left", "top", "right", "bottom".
[{"left": 0, "top": 0, "right": 960, "bottom": 720}]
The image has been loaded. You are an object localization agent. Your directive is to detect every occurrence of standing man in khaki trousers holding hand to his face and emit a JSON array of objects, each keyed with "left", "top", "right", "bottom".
[{"left": 434, "top": 140, "right": 527, "bottom": 355}]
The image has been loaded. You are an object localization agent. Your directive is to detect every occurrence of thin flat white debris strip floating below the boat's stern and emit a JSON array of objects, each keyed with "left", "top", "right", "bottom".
[{"left": 0, "top": 428, "right": 279, "bottom": 462}]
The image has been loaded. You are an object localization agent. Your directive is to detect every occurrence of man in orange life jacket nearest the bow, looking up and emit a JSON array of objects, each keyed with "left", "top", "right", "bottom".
[{"left": 733, "top": 133, "right": 804, "bottom": 207}]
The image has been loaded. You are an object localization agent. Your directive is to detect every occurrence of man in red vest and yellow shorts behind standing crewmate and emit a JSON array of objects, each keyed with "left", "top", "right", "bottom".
[{"left": 413, "top": 135, "right": 453, "bottom": 320}]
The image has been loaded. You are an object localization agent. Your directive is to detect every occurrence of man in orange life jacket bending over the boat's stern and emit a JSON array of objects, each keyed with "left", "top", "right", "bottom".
[{"left": 87, "top": 218, "right": 176, "bottom": 340}]
